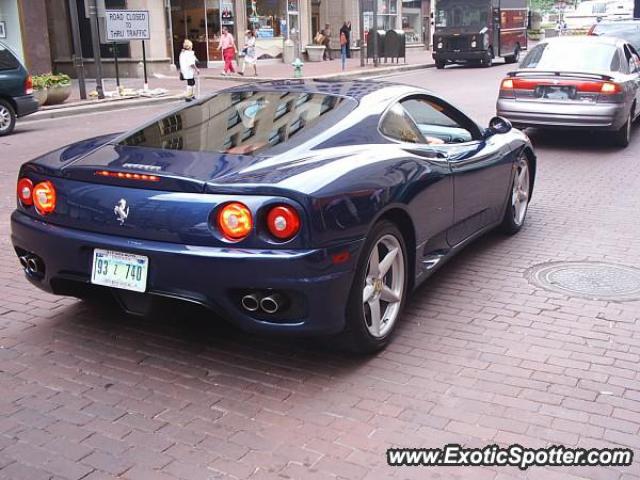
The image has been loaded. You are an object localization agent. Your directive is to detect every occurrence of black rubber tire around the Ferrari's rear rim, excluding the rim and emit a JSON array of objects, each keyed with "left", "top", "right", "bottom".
[{"left": 340, "top": 220, "right": 409, "bottom": 354}]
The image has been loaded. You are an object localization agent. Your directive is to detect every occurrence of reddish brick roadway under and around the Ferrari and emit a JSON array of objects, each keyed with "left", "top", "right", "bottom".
[{"left": 0, "top": 66, "right": 640, "bottom": 480}]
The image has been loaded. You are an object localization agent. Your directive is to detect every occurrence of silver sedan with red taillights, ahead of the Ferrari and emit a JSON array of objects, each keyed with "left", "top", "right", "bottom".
[{"left": 497, "top": 36, "right": 640, "bottom": 147}]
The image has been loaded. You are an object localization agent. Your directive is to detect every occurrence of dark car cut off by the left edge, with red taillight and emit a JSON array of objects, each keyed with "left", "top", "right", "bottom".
[{"left": 0, "top": 42, "right": 38, "bottom": 136}]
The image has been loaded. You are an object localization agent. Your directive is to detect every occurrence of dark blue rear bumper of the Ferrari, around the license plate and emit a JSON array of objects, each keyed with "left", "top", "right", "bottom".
[{"left": 11, "top": 211, "right": 364, "bottom": 335}]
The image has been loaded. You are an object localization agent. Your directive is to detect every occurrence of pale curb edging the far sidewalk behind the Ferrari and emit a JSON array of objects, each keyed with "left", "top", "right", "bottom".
[{"left": 21, "top": 63, "right": 435, "bottom": 122}]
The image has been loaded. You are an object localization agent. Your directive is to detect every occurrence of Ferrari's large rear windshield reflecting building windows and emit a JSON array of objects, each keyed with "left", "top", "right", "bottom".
[{"left": 120, "top": 91, "right": 355, "bottom": 155}]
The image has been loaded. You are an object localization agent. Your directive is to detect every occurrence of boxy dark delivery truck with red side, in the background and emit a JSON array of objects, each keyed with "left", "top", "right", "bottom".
[{"left": 433, "top": 0, "right": 529, "bottom": 68}]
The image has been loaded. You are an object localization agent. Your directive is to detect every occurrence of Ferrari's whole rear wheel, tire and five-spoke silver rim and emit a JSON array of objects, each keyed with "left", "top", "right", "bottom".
[{"left": 342, "top": 220, "right": 409, "bottom": 353}]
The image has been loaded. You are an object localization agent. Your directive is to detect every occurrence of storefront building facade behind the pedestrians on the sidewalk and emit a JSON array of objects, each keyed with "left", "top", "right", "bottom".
[{"left": 0, "top": 0, "right": 430, "bottom": 77}]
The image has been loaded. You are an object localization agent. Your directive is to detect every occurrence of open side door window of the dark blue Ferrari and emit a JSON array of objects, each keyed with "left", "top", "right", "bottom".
[{"left": 402, "top": 97, "right": 473, "bottom": 144}]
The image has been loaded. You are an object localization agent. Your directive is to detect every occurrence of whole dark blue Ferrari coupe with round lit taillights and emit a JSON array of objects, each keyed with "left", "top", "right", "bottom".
[{"left": 11, "top": 81, "right": 536, "bottom": 352}]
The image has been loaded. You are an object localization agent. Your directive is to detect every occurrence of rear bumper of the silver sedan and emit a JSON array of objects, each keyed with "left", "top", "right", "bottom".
[{"left": 496, "top": 98, "right": 628, "bottom": 130}]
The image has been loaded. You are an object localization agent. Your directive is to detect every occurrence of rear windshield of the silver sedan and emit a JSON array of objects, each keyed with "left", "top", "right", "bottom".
[{"left": 520, "top": 41, "right": 620, "bottom": 72}]
